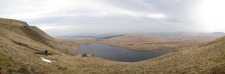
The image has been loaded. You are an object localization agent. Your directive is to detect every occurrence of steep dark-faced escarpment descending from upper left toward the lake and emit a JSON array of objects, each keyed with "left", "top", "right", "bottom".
[{"left": 0, "top": 18, "right": 79, "bottom": 55}]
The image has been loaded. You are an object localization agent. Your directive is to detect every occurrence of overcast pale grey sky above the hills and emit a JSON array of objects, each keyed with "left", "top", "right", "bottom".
[{"left": 0, "top": 0, "right": 225, "bottom": 37}]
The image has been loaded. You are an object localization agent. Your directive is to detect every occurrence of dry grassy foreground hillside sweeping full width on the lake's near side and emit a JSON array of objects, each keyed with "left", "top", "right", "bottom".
[{"left": 0, "top": 18, "right": 225, "bottom": 74}]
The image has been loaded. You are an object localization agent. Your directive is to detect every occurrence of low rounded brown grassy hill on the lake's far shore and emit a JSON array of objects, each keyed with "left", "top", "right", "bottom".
[{"left": 97, "top": 34, "right": 218, "bottom": 51}]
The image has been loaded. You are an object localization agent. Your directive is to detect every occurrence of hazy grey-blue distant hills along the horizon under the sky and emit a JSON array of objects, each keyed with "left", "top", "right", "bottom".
[{"left": 63, "top": 32, "right": 225, "bottom": 40}]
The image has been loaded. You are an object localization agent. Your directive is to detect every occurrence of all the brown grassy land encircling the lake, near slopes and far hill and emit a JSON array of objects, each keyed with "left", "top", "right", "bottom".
[{"left": 0, "top": 18, "right": 225, "bottom": 74}]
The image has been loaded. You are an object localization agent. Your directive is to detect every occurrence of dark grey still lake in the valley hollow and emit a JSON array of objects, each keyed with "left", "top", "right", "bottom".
[{"left": 75, "top": 43, "right": 172, "bottom": 62}]
